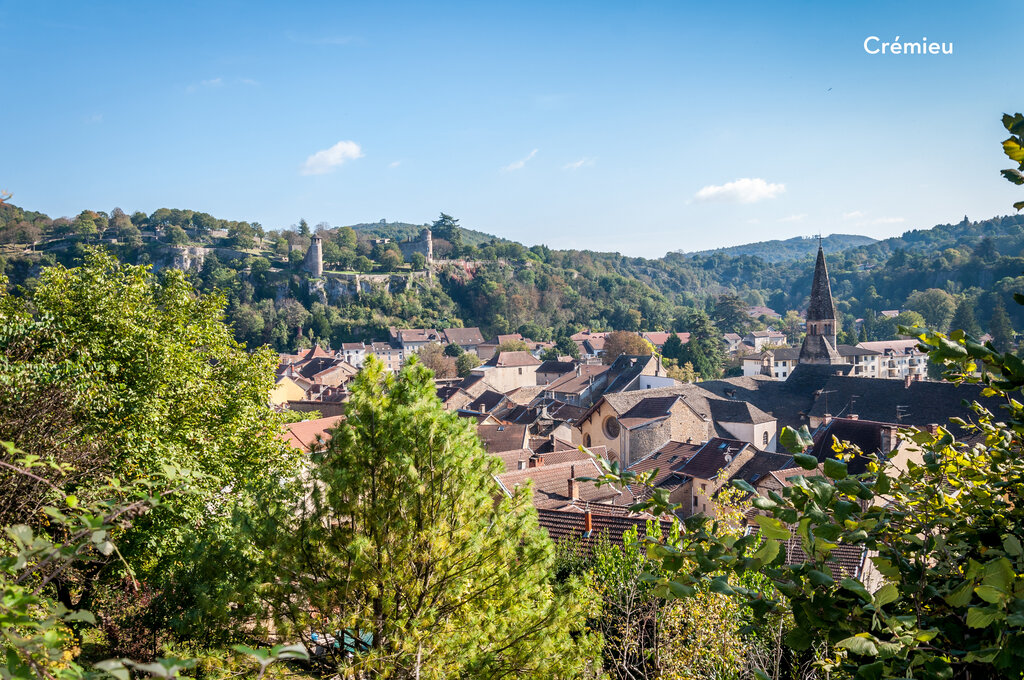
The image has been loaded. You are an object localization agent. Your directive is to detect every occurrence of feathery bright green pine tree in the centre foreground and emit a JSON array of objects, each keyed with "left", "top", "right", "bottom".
[{"left": 256, "top": 357, "right": 594, "bottom": 679}]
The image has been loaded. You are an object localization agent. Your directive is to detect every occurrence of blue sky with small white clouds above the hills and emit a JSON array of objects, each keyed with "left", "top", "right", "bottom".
[{"left": 0, "top": 0, "right": 1024, "bottom": 256}]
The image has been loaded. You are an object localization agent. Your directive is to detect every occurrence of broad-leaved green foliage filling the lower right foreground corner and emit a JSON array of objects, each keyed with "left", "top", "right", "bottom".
[{"left": 593, "top": 307, "right": 1024, "bottom": 680}]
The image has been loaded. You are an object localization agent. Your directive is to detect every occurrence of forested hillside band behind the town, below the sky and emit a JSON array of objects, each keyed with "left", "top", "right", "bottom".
[{"left": 0, "top": 205, "right": 1024, "bottom": 350}]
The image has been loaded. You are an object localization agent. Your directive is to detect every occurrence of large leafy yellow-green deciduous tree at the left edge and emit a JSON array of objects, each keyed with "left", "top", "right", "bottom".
[{"left": 0, "top": 250, "right": 298, "bottom": 637}]
